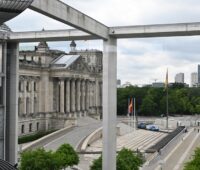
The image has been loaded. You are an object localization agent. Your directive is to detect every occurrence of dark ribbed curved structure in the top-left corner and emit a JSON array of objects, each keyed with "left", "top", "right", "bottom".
[{"left": 0, "top": 0, "right": 33, "bottom": 25}]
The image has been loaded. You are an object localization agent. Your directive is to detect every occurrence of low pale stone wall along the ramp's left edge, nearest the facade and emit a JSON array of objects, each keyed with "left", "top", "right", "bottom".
[{"left": 20, "top": 125, "right": 75, "bottom": 152}]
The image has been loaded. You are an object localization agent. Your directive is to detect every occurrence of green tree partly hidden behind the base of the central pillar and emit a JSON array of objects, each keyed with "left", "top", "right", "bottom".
[{"left": 90, "top": 148, "right": 143, "bottom": 170}]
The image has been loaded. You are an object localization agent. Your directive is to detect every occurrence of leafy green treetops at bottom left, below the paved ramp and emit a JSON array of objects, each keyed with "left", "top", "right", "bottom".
[{"left": 19, "top": 144, "right": 79, "bottom": 170}]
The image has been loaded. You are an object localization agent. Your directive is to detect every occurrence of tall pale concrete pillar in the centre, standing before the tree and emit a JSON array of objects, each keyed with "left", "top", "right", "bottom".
[{"left": 103, "top": 38, "right": 117, "bottom": 170}]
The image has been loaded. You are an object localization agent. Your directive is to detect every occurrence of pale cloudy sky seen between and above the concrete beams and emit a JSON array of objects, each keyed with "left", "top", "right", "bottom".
[{"left": 7, "top": 0, "right": 200, "bottom": 84}]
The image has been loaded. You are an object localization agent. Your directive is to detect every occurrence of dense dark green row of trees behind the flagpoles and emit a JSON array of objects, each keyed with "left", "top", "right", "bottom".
[{"left": 117, "top": 85, "right": 200, "bottom": 116}]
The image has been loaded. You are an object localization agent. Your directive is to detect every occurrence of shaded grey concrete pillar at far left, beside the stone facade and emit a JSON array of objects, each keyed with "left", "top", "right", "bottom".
[{"left": 6, "top": 43, "right": 19, "bottom": 164}]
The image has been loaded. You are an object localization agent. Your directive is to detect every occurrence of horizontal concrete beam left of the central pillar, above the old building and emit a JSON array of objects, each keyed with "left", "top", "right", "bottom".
[{"left": 8, "top": 29, "right": 96, "bottom": 42}]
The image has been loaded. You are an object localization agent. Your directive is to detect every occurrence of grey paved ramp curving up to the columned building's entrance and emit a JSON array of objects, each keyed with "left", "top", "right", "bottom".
[{"left": 44, "top": 117, "right": 102, "bottom": 151}]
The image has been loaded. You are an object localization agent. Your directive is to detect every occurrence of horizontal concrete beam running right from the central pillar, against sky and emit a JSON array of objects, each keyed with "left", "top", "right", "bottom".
[{"left": 109, "top": 22, "right": 200, "bottom": 38}]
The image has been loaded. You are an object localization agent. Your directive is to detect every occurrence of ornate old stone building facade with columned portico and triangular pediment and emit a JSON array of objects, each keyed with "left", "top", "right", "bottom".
[{"left": 18, "top": 41, "right": 102, "bottom": 136}]
